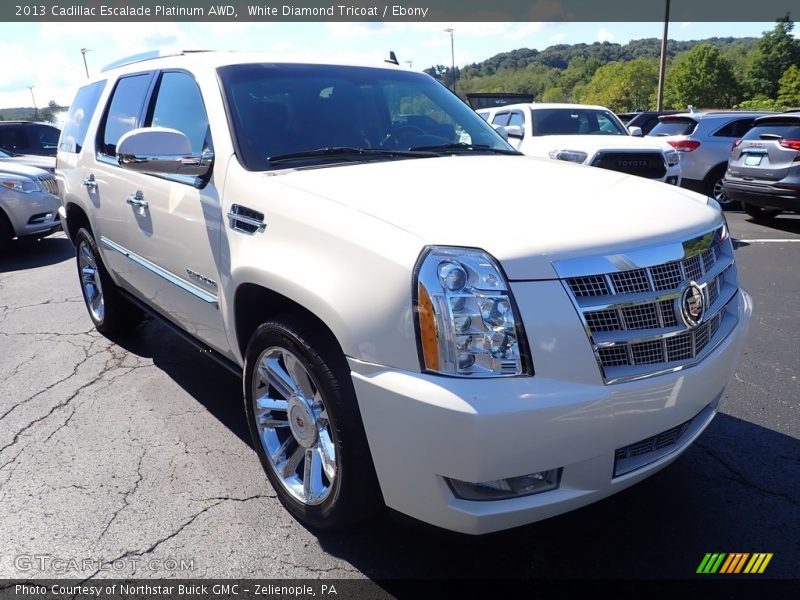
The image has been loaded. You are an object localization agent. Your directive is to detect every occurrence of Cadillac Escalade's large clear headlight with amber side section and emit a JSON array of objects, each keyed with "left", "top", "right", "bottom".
[{"left": 414, "top": 246, "right": 533, "bottom": 377}]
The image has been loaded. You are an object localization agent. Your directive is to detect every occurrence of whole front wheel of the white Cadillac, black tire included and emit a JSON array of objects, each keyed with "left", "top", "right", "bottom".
[{"left": 243, "top": 319, "right": 382, "bottom": 530}]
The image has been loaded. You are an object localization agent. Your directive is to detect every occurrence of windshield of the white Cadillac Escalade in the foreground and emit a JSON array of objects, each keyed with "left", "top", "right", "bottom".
[{"left": 219, "top": 64, "right": 513, "bottom": 171}]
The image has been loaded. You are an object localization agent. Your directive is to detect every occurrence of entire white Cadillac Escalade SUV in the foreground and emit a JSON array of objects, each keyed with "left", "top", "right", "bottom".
[{"left": 57, "top": 53, "right": 752, "bottom": 534}]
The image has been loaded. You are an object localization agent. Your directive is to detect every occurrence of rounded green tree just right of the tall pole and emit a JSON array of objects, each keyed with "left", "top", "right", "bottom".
[{"left": 665, "top": 44, "right": 739, "bottom": 108}]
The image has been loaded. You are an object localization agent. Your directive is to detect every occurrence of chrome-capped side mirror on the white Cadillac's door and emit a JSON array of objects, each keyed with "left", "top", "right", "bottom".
[{"left": 117, "top": 127, "right": 214, "bottom": 177}]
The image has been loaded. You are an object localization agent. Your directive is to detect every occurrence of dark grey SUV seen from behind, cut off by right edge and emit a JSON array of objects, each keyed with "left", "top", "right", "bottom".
[{"left": 724, "top": 112, "right": 800, "bottom": 218}]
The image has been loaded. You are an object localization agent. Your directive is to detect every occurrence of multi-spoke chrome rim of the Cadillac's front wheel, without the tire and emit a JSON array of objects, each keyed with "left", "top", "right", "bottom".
[{"left": 251, "top": 346, "right": 338, "bottom": 506}]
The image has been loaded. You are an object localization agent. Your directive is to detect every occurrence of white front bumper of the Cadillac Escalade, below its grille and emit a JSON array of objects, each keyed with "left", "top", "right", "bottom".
[{"left": 349, "top": 291, "right": 752, "bottom": 534}]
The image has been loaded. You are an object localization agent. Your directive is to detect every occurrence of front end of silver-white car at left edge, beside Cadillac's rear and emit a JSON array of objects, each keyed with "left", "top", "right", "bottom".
[{"left": 0, "top": 160, "right": 61, "bottom": 247}]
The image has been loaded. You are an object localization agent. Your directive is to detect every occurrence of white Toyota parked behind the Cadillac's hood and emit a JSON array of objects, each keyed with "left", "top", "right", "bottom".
[{"left": 477, "top": 102, "right": 681, "bottom": 185}]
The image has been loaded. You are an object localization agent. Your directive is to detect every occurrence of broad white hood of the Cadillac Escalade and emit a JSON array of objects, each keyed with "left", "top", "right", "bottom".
[{"left": 278, "top": 155, "right": 721, "bottom": 280}]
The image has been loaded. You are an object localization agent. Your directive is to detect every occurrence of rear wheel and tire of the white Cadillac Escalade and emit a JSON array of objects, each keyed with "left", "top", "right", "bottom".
[{"left": 75, "top": 229, "right": 142, "bottom": 335}]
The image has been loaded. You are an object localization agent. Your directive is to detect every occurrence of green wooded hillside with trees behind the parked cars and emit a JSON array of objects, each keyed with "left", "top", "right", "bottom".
[{"left": 426, "top": 16, "right": 800, "bottom": 112}]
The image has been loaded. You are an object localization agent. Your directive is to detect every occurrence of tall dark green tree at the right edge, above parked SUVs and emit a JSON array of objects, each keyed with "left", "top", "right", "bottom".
[{"left": 745, "top": 15, "right": 800, "bottom": 98}]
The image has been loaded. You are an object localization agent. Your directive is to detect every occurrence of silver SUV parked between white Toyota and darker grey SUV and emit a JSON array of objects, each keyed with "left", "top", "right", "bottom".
[{"left": 648, "top": 111, "right": 771, "bottom": 208}]
